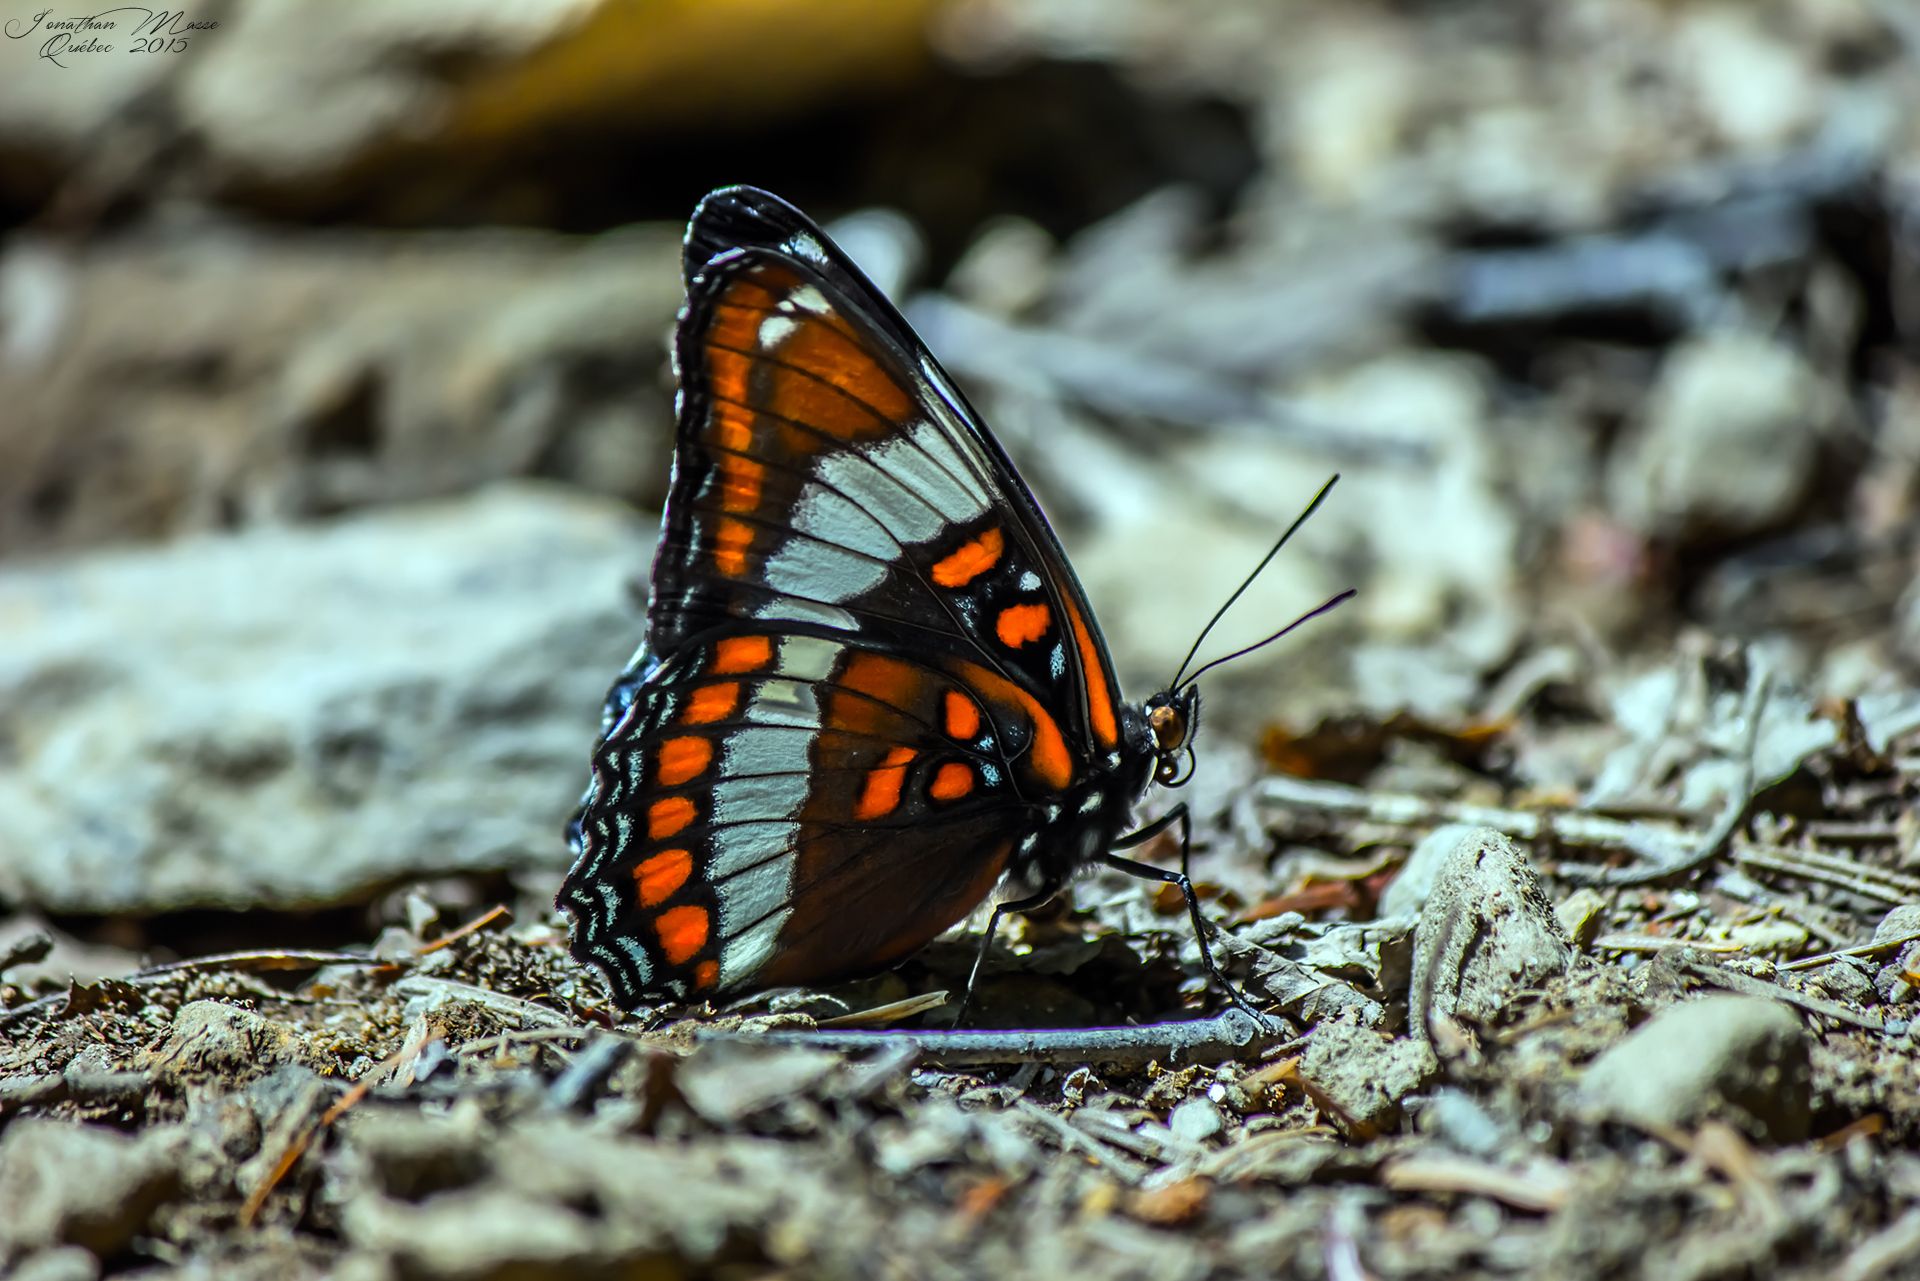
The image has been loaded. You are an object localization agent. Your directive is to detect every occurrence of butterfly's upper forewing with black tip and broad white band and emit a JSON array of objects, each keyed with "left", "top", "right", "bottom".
[{"left": 649, "top": 188, "right": 1117, "bottom": 751}]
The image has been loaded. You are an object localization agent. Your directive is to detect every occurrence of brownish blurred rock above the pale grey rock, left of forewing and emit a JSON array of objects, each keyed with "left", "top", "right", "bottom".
[{"left": 0, "top": 227, "right": 680, "bottom": 553}]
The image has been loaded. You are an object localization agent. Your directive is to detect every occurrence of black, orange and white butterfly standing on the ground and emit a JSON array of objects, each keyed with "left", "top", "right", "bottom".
[{"left": 557, "top": 186, "right": 1338, "bottom": 1008}]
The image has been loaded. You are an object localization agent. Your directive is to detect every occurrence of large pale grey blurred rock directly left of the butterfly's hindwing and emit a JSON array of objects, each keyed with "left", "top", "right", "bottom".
[{"left": 0, "top": 488, "right": 647, "bottom": 912}]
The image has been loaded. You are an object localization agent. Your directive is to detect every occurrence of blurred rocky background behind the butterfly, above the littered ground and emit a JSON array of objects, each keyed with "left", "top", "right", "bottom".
[{"left": 0, "top": 0, "right": 1920, "bottom": 971}]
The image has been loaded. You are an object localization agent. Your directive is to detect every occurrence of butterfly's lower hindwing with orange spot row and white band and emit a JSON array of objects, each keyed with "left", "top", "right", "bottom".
[{"left": 561, "top": 634, "right": 1012, "bottom": 1004}]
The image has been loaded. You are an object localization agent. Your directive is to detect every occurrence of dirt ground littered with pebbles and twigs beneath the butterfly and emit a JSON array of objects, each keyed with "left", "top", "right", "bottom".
[{"left": 0, "top": 760, "right": 1920, "bottom": 1277}]
